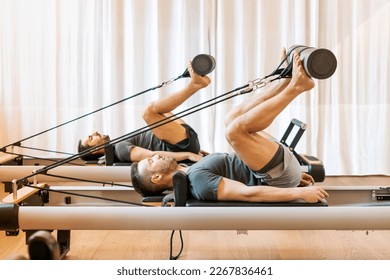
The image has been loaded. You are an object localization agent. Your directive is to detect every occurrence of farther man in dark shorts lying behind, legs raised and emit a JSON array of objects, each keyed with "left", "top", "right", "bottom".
[{"left": 78, "top": 62, "right": 210, "bottom": 162}]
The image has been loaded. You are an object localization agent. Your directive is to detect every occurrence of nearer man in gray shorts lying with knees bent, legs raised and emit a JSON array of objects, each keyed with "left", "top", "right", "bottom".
[{"left": 131, "top": 52, "right": 328, "bottom": 203}]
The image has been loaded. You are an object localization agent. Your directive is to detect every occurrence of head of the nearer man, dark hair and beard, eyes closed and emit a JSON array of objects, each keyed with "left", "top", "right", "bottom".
[{"left": 131, "top": 154, "right": 177, "bottom": 197}]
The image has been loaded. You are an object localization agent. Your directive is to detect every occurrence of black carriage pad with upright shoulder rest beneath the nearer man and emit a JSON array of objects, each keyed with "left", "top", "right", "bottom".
[{"left": 173, "top": 171, "right": 328, "bottom": 207}]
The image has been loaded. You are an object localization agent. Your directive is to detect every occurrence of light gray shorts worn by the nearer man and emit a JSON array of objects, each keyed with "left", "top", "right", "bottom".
[{"left": 253, "top": 145, "right": 301, "bottom": 188}]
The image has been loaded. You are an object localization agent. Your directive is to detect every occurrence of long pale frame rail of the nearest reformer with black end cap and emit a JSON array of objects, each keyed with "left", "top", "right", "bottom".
[{"left": 0, "top": 204, "right": 390, "bottom": 230}]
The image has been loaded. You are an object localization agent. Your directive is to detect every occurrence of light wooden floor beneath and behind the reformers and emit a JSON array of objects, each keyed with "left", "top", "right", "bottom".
[{"left": 0, "top": 176, "right": 390, "bottom": 260}]
